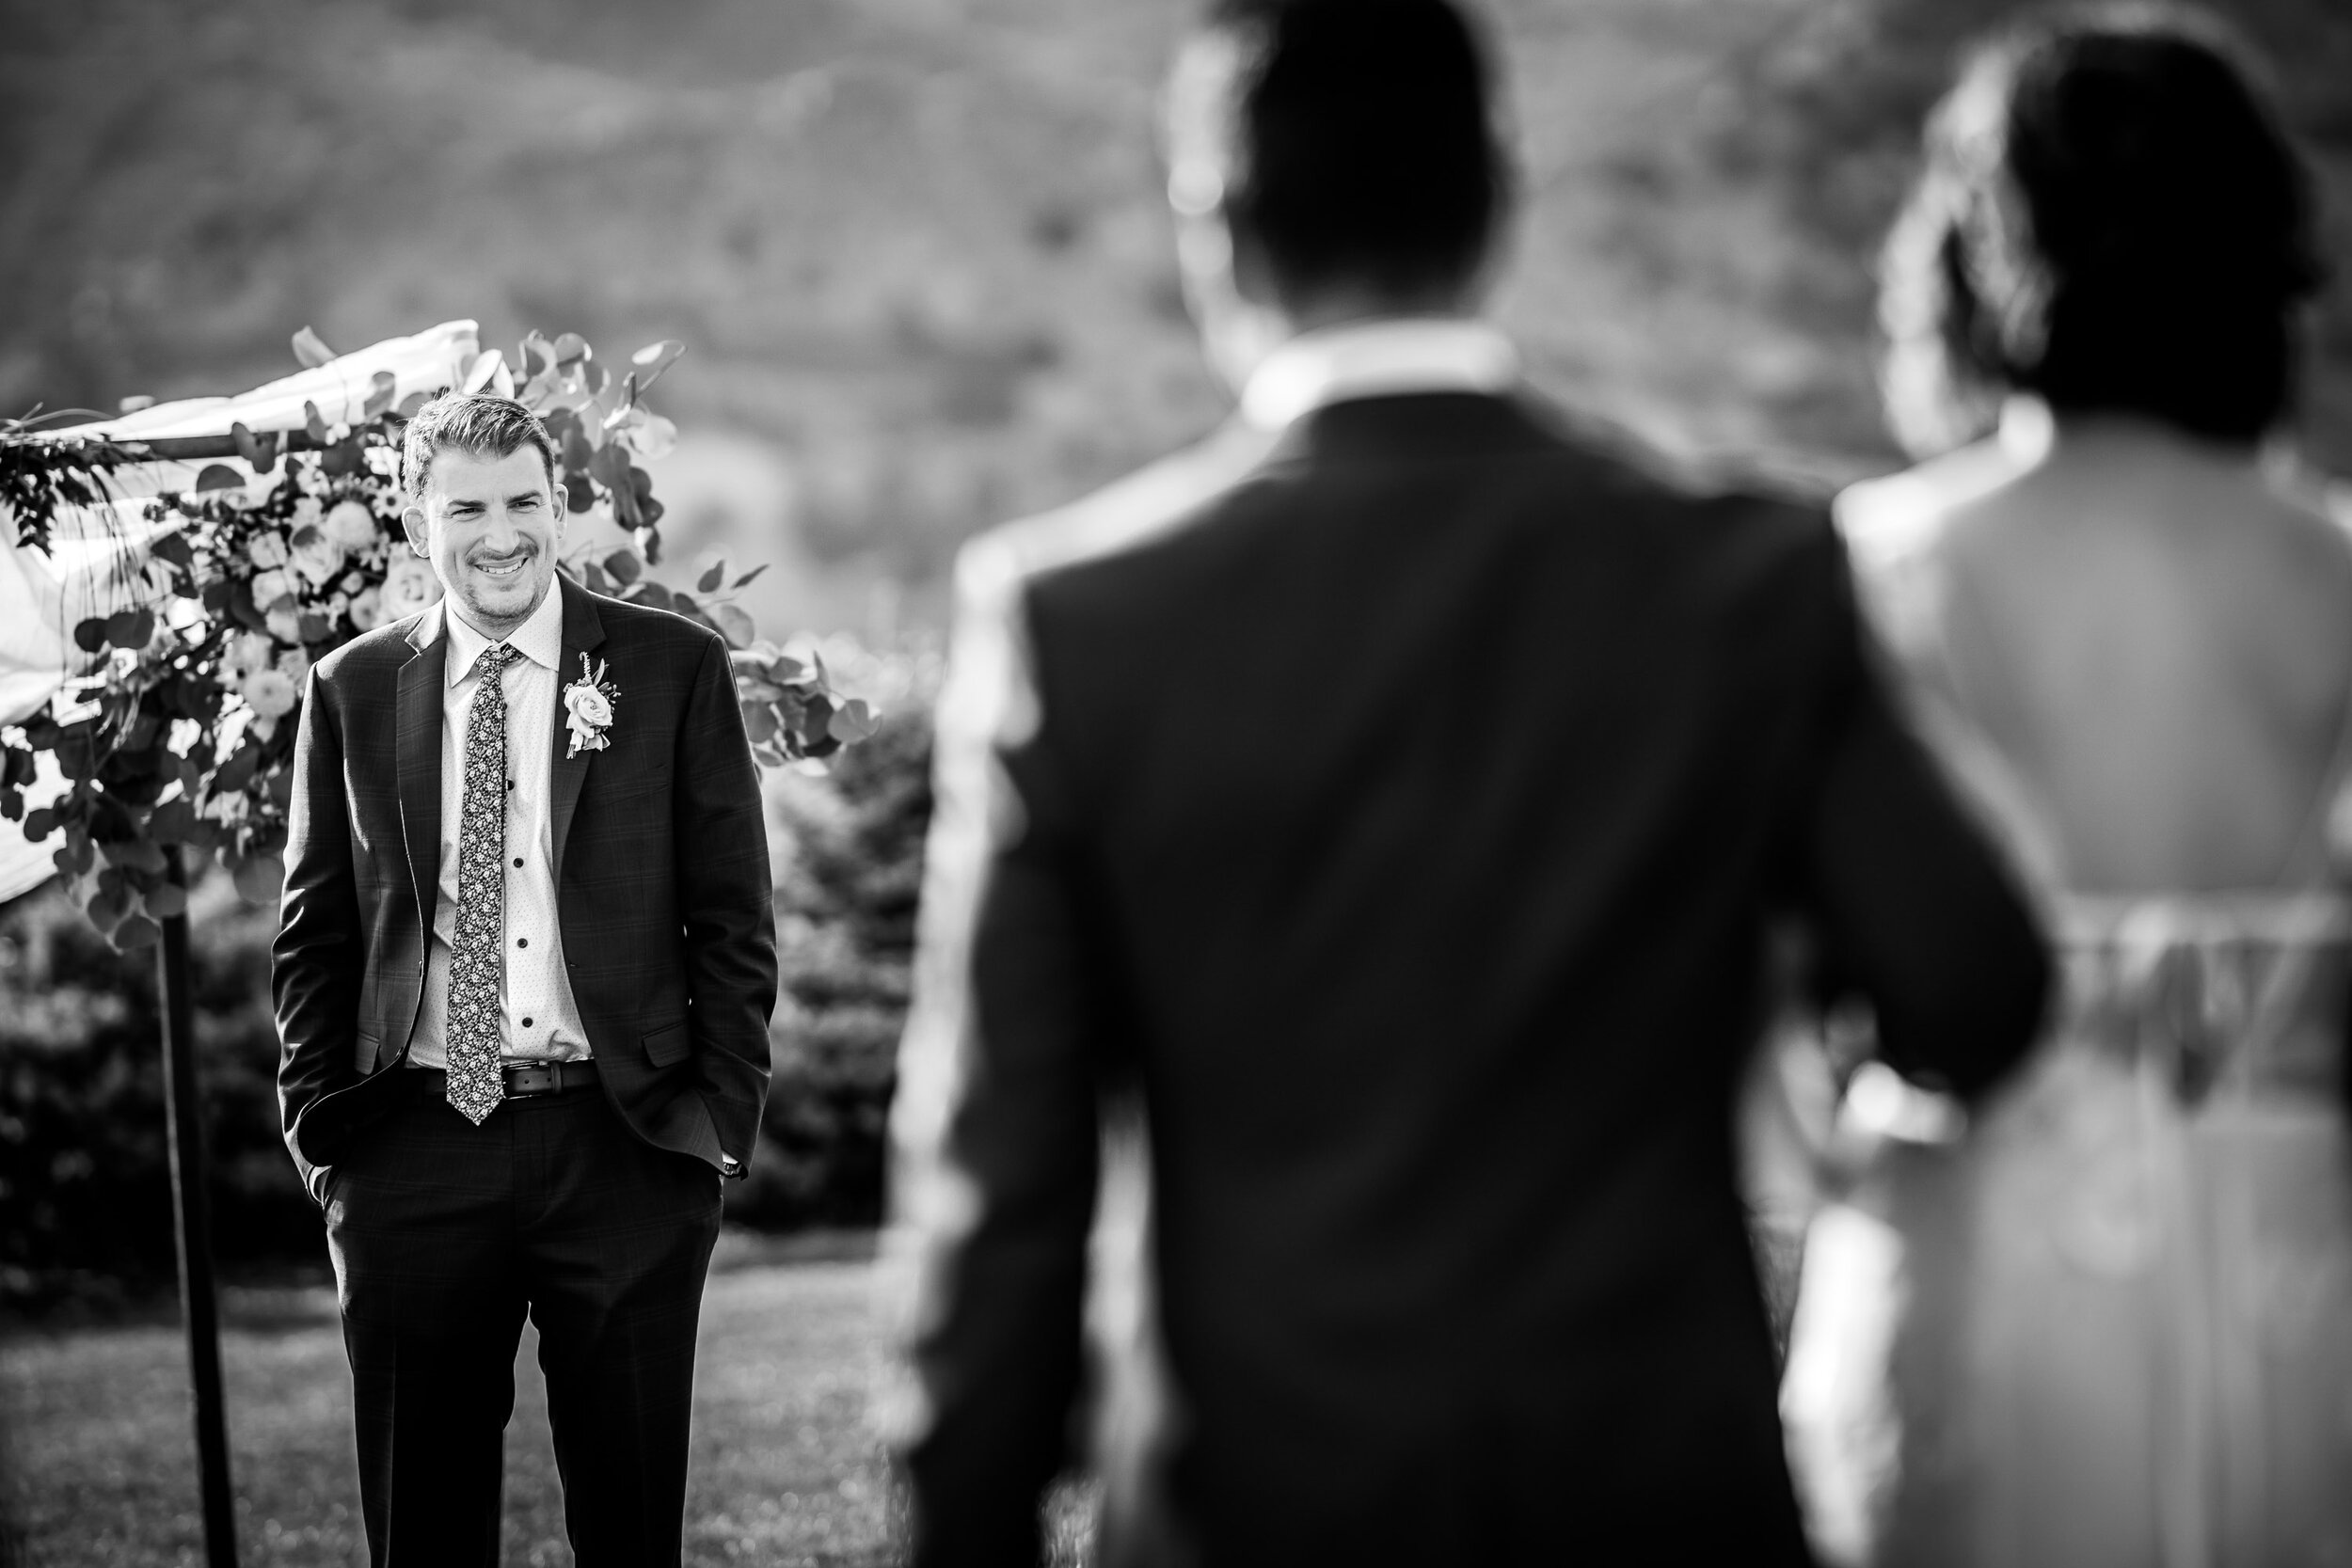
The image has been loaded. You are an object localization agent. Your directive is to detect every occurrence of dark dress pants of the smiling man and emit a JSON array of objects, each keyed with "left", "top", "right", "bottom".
[{"left": 327, "top": 1074, "right": 720, "bottom": 1568}]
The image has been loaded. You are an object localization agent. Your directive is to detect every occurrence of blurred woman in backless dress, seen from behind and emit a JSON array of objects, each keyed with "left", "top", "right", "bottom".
[{"left": 1783, "top": 9, "right": 2352, "bottom": 1568}]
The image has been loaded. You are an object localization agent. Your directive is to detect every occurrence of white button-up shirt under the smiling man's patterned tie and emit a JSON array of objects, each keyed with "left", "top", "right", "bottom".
[{"left": 409, "top": 583, "right": 588, "bottom": 1068}]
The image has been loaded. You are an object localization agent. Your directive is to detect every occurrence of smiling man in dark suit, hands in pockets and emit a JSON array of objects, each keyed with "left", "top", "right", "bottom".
[{"left": 273, "top": 395, "right": 776, "bottom": 1568}]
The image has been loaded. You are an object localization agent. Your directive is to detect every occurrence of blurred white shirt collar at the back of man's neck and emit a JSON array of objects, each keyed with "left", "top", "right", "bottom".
[{"left": 1242, "top": 317, "right": 1519, "bottom": 430}]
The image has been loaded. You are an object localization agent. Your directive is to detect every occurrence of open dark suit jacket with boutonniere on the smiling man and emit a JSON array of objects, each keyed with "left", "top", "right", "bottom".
[{"left": 271, "top": 576, "right": 776, "bottom": 1192}]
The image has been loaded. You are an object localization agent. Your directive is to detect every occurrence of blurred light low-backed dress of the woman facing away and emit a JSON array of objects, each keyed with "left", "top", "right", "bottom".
[{"left": 1783, "top": 491, "right": 2352, "bottom": 1568}]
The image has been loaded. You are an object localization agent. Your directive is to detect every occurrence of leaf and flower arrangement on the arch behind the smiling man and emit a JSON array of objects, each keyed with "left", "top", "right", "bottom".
[{"left": 0, "top": 326, "right": 873, "bottom": 952}]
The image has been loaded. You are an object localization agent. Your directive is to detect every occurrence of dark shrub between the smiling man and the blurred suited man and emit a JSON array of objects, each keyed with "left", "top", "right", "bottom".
[{"left": 727, "top": 705, "right": 931, "bottom": 1227}]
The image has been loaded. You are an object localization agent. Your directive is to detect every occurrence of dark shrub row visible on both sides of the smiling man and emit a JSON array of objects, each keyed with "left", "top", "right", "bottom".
[{"left": 0, "top": 701, "right": 931, "bottom": 1309}]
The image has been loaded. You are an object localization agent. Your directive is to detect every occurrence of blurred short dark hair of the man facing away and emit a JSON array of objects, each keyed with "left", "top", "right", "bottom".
[{"left": 1209, "top": 0, "right": 1510, "bottom": 296}]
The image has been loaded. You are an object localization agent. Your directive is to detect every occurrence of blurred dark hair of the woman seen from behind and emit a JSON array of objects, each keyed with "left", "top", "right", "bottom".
[{"left": 1880, "top": 5, "right": 2324, "bottom": 456}]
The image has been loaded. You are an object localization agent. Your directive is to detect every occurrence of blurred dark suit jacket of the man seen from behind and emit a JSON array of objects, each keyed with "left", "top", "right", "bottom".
[{"left": 897, "top": 395, "right": 2046, "bottom": 1566}]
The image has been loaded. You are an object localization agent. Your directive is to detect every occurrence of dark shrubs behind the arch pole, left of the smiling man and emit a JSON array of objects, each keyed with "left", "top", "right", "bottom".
[{"left": 0, "top": 877, "right": 323, "bottom": 1307}]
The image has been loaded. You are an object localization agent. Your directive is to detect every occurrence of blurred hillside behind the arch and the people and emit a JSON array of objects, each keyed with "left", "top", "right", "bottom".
[{"left": 0, "top": 0, "right": 2352, "bottom": 641}]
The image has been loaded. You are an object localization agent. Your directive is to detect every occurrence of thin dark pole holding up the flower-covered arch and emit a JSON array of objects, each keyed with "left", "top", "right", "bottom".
[{"left": 155, "top": 847, "right": 238, "bottom": 1568}]
